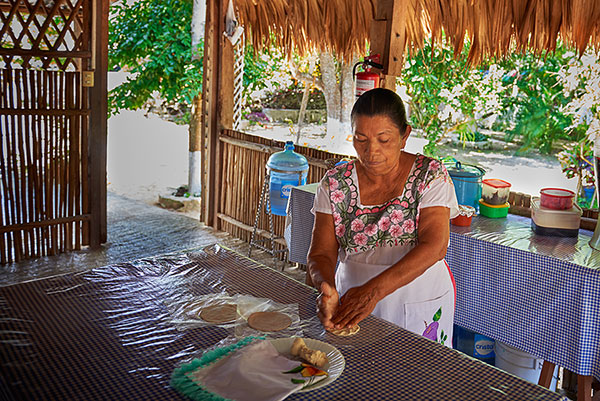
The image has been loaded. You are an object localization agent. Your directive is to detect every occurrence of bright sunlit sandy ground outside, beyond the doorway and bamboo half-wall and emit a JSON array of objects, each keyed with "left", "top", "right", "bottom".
[{"left": 107, "top": 73, "right": 577, "bottom": 204}]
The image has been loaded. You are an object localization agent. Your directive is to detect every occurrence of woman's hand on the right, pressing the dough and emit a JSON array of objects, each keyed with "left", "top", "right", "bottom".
[{"left": 331, "top": 283, "right": 380, "bottom": 329}]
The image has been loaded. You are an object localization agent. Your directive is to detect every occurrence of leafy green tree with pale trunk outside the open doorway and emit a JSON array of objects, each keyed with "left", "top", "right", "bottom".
[{"left": 109, "top": 0, "right": 278, "bottom": 194}]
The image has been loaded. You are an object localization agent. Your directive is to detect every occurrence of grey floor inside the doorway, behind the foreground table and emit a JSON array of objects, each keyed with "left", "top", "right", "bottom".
[{"left": 0, "top": 192, "right": 304, "bottom": 286}]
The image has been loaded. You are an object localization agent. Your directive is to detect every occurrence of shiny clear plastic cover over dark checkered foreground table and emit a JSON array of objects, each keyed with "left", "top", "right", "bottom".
[{"left": 0, "top": 246, "right": 563, "bottom": 400}]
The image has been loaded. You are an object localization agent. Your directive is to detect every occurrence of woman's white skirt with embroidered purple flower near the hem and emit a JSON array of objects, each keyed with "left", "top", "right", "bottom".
[{"left": 335, "top": 260, "right": 455, "bottom": 347}]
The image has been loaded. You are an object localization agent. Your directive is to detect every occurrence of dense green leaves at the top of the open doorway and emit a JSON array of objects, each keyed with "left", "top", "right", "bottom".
[{"left": 109, "top": 0, "right": 202, "bottom": 113}]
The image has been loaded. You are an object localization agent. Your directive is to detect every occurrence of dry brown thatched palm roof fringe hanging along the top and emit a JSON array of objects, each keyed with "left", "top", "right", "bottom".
[{"left": 234, "top": 0, "right": 600, "bottom": 63}]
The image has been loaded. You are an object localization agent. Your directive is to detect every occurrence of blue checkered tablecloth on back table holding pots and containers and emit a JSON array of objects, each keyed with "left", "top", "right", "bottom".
[{"left": 289, "top": 183, "right": 600, "bottom": 378}]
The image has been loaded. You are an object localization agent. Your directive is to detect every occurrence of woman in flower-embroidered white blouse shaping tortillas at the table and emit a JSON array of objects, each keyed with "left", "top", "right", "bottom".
[{"left": 308, "top": 89, "right": 458, "bottom": 345}]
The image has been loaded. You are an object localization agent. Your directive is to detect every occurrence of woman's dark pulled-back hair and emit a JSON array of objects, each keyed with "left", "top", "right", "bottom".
[{"left": 350, "top": 88, "right": 408, "bottom": 135}]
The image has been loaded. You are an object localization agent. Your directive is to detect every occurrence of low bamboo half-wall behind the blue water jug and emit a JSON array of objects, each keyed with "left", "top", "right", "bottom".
[{"left": 218, "top": 130, "right": 345, "bottom": 256}]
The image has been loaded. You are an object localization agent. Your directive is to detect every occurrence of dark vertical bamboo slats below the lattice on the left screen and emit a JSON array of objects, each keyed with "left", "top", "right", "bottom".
[{"left": 0, "top": 69, "right": 89, "bottom": 263}]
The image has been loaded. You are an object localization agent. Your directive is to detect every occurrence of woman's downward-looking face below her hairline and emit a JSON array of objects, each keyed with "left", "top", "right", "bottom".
[{"left": 352, "top": 115, "right": 410, "bottom": 175}]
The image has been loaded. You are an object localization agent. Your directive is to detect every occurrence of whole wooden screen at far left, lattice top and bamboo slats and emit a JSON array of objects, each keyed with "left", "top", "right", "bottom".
[{"left": 0, "top": 0, "right": 94, "bottom": 263}]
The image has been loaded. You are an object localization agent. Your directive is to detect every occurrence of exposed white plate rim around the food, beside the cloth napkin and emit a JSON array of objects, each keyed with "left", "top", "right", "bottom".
[{"left": 269, "top": 337, "right": 346, "bottom": 392}]
